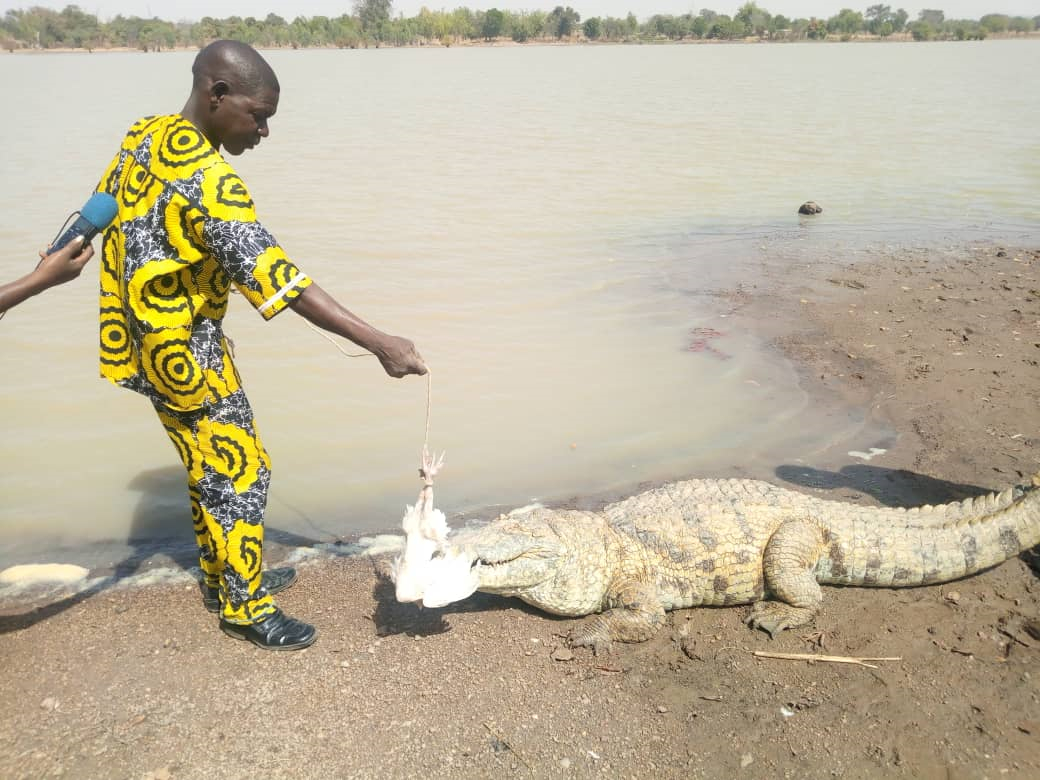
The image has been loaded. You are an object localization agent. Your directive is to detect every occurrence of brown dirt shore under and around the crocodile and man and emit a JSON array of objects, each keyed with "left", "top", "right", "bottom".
[{"left": 0, "top": 245, "right": 1040, "bottom": 780}]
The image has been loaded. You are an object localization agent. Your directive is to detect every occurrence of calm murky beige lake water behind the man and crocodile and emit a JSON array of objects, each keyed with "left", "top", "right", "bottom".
[{"left": 0, "top": 41, "right": 1040, "bottom": 566}]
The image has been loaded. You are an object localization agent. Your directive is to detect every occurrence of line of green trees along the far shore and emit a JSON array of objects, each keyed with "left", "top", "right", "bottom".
[{"left": 0, "top": 0, "right": 1040, "bottom": 51}]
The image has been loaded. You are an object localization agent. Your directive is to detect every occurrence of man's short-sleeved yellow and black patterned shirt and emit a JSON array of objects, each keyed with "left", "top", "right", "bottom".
[{"left": 98, "top": 114, "right": 311, "bottom": 411}]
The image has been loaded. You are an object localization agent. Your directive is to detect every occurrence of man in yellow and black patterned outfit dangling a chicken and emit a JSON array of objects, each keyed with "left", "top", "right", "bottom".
[{"left": 98, "top": 41, "right": 426, "bottom": 649}]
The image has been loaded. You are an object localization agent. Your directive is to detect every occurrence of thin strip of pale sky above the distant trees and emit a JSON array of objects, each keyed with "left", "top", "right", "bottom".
[{"left": 0, "top": 0, "right": 1040, "bottom": 22}]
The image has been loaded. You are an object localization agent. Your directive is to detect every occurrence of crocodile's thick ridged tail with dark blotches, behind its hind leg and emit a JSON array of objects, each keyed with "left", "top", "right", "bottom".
[{"left": 816, "top": 486, "right": 1040, "bottom": 588}]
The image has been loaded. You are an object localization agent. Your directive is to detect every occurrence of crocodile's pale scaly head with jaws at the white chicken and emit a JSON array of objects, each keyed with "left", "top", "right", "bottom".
[{"left": 423, "top": 510, "right": 607, "bottom": 615}]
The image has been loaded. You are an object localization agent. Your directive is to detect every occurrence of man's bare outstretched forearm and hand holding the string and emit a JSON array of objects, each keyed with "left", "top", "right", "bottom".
[{"left": 289, "top": 282, "right": 426, "bottom": 376}]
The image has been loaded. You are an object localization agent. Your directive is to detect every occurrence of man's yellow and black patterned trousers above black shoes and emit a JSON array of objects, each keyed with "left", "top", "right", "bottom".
[{"left": 155, "top": 390, "right": 275, "bottom": 624}]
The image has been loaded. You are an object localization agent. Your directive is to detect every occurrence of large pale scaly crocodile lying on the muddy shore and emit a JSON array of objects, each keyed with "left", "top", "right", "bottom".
[{"left": 423, "top": 474, "right": 1040, "bottom": 653}]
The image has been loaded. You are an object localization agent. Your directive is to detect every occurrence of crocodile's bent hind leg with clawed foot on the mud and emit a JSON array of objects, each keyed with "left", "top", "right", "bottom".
[{"left": 745, "top": 520, "right": 824, "bottom": 638}]
